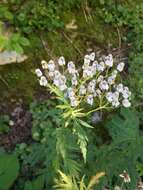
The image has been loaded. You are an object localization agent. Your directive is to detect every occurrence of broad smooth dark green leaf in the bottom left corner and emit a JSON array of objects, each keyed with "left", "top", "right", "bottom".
[{"left": 0, "top": 154, "right": 19, "bottom": 190}]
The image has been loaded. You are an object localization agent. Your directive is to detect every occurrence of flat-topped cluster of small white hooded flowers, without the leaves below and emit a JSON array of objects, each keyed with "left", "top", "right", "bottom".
[{"left": 35, "top": 52, "right": 131, "bottom": 111}]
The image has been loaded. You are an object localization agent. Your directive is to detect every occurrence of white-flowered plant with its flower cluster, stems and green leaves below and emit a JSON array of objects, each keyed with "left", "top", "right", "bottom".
[{"left": 35, "top": 52, "right": 131, "bottom": 161}]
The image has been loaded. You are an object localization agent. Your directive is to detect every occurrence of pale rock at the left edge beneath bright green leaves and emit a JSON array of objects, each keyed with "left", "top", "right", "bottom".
[{"left": 0, "top": 51, "right": 28, "bottom": 65}]
